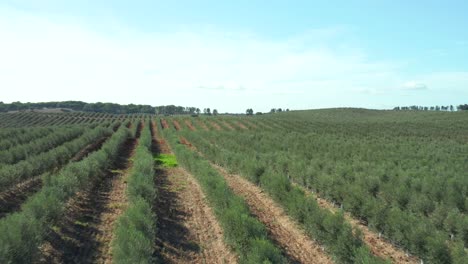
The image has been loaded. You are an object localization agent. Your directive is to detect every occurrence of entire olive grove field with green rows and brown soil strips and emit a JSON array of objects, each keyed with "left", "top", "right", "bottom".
[{"left": 0, "top": 109, "right": 468, "bottom": 263}]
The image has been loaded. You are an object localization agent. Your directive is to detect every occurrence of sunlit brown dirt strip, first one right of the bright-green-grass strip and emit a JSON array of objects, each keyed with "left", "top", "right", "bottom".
[{"left": 212, "top": 164, "right": 333, "bottom": 263}]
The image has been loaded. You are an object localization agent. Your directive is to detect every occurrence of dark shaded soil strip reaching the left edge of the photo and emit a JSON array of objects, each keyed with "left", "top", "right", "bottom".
[{"left": 0, "top": 137, "right": 108, "bottom": 218}]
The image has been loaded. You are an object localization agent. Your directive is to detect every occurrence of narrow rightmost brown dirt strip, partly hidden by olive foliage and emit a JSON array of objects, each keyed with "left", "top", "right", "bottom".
[{"left": 294, "top": 184, "right": 419, "bottom": 264}]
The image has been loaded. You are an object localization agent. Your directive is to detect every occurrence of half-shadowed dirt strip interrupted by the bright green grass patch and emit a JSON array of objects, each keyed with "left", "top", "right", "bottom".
[{"left": 153, "top": 120, "right": 237, "bottom": 263}]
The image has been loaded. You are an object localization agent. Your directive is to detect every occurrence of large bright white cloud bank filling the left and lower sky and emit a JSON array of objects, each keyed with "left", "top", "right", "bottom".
[{"left": 0, "top": 5, "right": 464, "bottom": 112}]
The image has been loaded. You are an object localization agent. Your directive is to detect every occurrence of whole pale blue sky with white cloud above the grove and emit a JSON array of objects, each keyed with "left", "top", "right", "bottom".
[{"left": 0, "top": 0, "right": 468, "bottom": 112}]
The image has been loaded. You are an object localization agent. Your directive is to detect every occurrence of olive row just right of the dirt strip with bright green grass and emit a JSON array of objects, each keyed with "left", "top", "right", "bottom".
[{"left": 165, "top": 132, "right": 286, "bottom": 263}]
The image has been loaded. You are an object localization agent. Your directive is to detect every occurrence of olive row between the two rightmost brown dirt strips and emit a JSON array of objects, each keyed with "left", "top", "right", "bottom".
[{"left": 179, "top": 133, "right": 385, "bottom": 263}]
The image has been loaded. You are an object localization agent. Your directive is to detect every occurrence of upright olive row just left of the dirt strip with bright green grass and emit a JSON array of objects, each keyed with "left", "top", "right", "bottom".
[{"left": 112, "top": 122, "right": 156, "bottom": 263}]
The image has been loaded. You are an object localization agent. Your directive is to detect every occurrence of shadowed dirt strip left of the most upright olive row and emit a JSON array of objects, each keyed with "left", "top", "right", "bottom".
[{"left": 39, "top": 123, "right": 142, "bottom": 263}]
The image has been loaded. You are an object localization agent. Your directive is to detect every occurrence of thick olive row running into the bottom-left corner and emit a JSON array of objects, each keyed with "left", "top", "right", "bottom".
[{"left": 0, "top": 127, "right": 129, "bottom": 263}]
